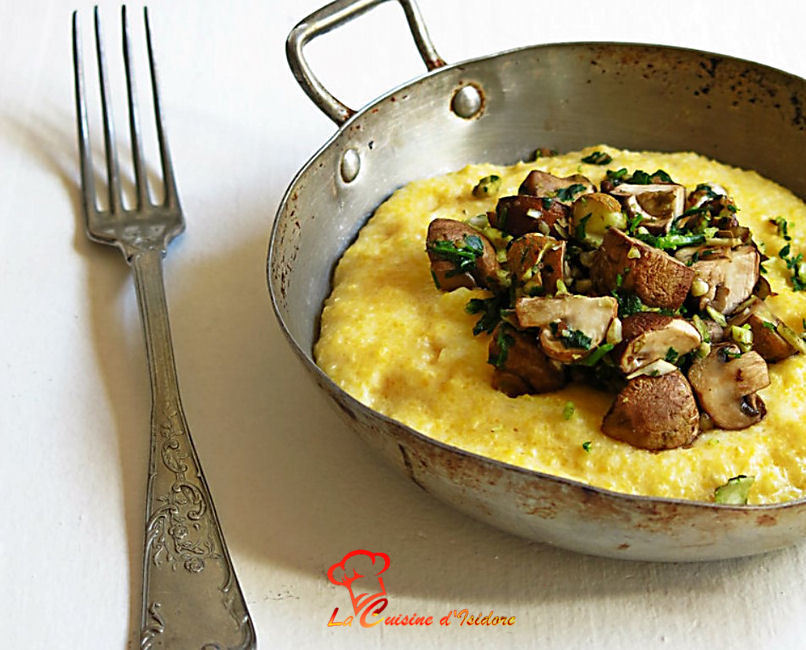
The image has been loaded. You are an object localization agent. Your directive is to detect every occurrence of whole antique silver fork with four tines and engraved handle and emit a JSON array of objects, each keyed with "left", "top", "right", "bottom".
[{"left": 73, "top": 6, "right": 255, "bottom": 650}]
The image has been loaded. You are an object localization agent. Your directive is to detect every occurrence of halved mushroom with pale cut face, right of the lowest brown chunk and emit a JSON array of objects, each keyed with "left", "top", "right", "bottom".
[{"left": 688, "top": 343, "right": 770, "bottom": 429}]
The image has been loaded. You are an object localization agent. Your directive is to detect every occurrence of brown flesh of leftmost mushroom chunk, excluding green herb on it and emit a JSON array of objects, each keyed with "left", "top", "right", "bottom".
[{"left": 426, "top": 219, "right": 501, "bottom": 291}]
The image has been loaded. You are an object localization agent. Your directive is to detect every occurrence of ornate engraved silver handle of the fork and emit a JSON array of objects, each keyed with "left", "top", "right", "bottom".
[{"left": 129, "top": 249, "right": 255, "bottom": 650}]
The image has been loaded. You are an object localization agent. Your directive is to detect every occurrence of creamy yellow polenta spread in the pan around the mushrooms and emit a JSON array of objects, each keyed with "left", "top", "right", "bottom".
[{"left": 315, "top": 146, "right": 806, "bottom": 503}]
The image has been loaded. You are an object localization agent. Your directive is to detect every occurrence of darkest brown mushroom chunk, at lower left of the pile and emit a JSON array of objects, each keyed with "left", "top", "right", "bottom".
[{"left": 489, "top": 325, "right": 566, "bottom": 397}]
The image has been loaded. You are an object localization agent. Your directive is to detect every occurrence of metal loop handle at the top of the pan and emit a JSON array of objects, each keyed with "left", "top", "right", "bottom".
[{"left": 285, "top": 0, "right": 445, "bottom": 126}]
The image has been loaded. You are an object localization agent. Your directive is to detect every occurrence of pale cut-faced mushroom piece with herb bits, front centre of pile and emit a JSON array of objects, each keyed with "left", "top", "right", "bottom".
[{"left": 515, "top": 294, "right": 618, "bottom": 363}]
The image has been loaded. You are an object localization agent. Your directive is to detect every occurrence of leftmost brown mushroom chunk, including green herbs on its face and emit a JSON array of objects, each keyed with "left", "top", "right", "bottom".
[{"left": 426, "top": 219, "right": 501, "bottom": 291}]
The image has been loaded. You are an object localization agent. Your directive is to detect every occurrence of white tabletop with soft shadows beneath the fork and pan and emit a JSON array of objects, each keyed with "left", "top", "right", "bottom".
[{"left": 0, "top": 0, "right": 806, "bottom": 650}]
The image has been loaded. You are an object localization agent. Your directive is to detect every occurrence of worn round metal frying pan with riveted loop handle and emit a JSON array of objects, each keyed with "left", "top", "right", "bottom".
[{"left": 268, "top": 0, "right": 806, "bottom": 561}]
